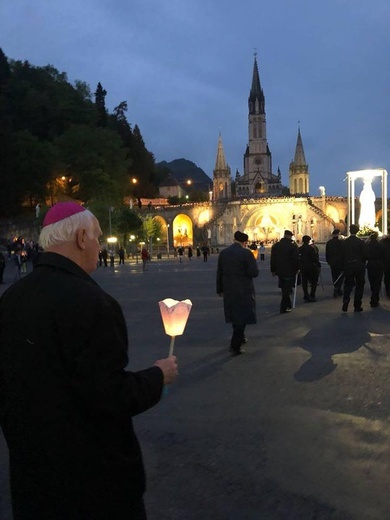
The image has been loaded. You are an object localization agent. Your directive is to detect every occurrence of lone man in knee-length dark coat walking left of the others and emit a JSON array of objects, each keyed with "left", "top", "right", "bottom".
[{"left": 217, "top": 231, "right": 259, "bottom": 356}]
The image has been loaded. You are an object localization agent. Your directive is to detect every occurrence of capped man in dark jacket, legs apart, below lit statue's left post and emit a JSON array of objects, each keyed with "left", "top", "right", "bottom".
[{"left": 342, "top": 224, "right": 366, "bottom": 312}]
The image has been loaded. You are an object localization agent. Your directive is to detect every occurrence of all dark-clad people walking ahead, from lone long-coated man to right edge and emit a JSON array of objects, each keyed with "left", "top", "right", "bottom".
[{"left": 216, "top": 224, "right": 390, "bottom": 356}]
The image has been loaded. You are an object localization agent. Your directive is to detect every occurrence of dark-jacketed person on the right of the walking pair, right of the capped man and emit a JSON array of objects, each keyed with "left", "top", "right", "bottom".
[{"left": 298, "top": 235, "right": 321, "bottom": 302}]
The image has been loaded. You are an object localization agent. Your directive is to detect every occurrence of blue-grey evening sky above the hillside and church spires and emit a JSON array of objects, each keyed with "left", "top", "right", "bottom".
[{"left": 0, "top": 0, "right": 390, "bottom": 195}]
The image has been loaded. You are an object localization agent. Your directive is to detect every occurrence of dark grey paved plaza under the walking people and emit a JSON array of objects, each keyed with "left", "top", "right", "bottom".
[{"left": 0, "top": 252, "right": 390, "bottom": 520}]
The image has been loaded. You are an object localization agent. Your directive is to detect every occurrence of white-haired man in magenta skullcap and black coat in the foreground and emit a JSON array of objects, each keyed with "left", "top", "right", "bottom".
[{"left": 0, "top": 202, "right": 177, "bottom": 520}]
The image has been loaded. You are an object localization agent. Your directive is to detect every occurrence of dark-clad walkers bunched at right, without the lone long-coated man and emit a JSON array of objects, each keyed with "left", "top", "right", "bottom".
[{"left": 271, "top": 224, "right": 390, "bottom": 313}]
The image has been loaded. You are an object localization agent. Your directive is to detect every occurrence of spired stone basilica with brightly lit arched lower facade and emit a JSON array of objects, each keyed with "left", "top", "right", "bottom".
[{"left": 209, "top": 55, "right": 348, "bottom": 245}]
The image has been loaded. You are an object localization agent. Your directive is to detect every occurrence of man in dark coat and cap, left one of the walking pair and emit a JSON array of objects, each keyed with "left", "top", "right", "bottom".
[{"left": 271, "top": 230, "right": 299, "bottom": 314}]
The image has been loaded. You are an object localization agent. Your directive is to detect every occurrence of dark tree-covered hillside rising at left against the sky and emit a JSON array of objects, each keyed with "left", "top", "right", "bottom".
[{"left": 0, "top": 49, "right": 158, "bottom": 217}]
